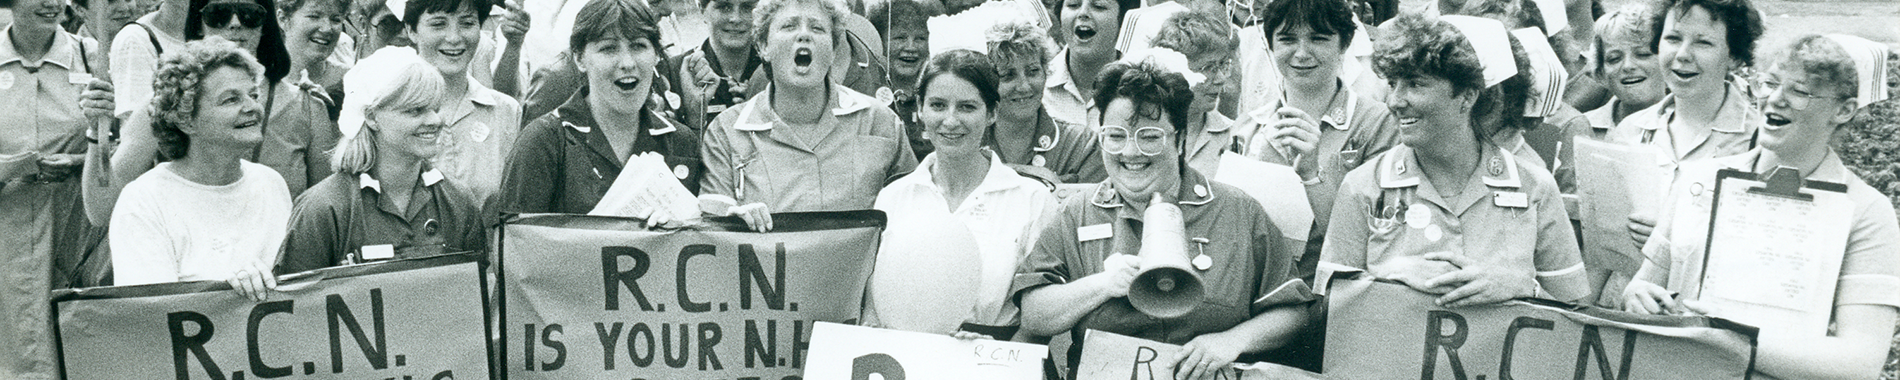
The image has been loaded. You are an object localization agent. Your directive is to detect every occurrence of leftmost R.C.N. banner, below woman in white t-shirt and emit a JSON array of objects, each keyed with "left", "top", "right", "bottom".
[{"left": 53, "top": 255, "right": 488, "bottom": 380}]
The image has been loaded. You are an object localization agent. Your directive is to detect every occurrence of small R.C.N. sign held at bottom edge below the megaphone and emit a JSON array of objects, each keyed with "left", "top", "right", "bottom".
[{"left": 1075, "top": 331, "right": 1324, "bottom": 380}]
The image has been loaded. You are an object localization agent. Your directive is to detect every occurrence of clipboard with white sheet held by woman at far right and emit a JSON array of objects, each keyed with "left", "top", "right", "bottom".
[{"left": 1691, "top": 167, "right": 1853, "bottom": 336}]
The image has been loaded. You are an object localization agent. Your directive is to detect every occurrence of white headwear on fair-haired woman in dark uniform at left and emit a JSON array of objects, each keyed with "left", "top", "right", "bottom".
[{"left": 336, "top": 46, "right": 435, "bottom": 141}]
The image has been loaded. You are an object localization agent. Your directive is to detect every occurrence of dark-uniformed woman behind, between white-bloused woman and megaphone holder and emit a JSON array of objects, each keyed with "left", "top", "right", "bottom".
[{"left": 984, "top": 17, "right": 1108, "bottom": 184}]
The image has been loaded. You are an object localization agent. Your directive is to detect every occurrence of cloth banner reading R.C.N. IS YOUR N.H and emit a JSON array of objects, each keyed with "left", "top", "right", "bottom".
[{"left": 498, "top": 211, "right": 885, "bottom": 380}]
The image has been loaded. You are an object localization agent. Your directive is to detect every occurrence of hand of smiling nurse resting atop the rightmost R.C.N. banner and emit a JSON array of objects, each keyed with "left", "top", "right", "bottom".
[{"left": 1425, "top": 253, "right": 1537, "bottom": 308}]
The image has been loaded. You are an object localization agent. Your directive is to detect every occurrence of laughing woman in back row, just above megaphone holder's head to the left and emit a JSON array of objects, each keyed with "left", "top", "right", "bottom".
[{"left": 1043, "top": 0, "right": 1142, "bottom": 127}]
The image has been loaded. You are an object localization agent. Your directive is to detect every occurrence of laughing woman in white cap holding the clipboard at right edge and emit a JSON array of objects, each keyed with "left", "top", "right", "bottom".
[{"left": 1621, "top": 34, "right": 1900, "bottom": 378}]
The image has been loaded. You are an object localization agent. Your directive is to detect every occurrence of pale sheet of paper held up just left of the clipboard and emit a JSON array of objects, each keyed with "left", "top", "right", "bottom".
[{"left": 1575, "top": 139, "right": 1666, "bottom": 274}]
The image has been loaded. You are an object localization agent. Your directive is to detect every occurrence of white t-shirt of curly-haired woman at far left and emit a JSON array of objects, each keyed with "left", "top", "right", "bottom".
[{"left": 108, "top": 162, "right": 291, "bottom": 285}]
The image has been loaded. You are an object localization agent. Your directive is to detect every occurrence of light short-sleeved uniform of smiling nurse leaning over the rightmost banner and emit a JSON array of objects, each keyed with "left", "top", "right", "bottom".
[{"left": 1321, "top": 144, "right": 1590, "bottom": 300}]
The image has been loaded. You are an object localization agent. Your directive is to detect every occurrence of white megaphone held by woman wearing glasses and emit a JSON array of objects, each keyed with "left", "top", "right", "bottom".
[{"left": 1129, "top": 194, "right": 1207, "bottom": 319}]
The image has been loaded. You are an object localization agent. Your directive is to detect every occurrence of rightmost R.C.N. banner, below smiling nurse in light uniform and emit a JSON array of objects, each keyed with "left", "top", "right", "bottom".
[{"left": 1322, "top": 279, "right": 1756, "bottom": 380}]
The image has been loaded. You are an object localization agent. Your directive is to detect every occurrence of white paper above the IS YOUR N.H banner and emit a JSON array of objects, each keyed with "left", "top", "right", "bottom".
[{"left": 587, "top": 152, "right": 699, "bottom": 220}]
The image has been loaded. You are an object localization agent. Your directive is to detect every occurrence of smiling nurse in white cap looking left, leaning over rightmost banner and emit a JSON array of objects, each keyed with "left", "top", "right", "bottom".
[{"left": 1321, "top": 13, "right": 1590, "bottom": 308}]
